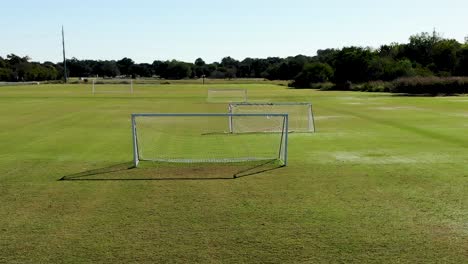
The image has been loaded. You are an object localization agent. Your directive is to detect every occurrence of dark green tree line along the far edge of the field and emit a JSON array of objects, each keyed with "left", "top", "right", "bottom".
[{"left": 0, "top": 31, "right": 468, "bottom": 88}]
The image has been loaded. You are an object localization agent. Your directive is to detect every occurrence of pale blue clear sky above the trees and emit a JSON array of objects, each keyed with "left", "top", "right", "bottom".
[{"left": 0, "top": 0, "right": 468, "bottom": 63}]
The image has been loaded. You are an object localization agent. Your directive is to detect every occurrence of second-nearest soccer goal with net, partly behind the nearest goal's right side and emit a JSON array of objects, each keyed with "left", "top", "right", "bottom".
[{"left": 229, "top": 102, "right": 315, "bottom": 132}]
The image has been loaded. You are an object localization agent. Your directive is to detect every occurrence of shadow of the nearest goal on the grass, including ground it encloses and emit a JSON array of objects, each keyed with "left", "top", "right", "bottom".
[{"left": 59, "top": 160, "right": 284, "bottom": 181}]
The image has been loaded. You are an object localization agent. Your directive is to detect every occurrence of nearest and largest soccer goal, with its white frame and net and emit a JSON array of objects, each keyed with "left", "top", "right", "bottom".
[{"left": 132, "top": 114, "right": 288, "bottom": 167}]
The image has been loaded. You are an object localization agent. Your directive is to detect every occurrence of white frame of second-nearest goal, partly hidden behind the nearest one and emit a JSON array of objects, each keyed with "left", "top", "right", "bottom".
[{"left": 228, "top": 102, "right": 316, "bottom": 132}]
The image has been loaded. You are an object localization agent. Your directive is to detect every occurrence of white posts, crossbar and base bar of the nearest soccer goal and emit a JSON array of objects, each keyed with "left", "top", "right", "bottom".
[{"left": 131, "top": 113, "right": 288, "bottom": 168}]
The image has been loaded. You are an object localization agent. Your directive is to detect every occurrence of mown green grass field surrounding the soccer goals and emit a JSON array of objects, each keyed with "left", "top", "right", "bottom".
[{"left": 0, "top": 83, "right": 468, "bottom": 263}]
